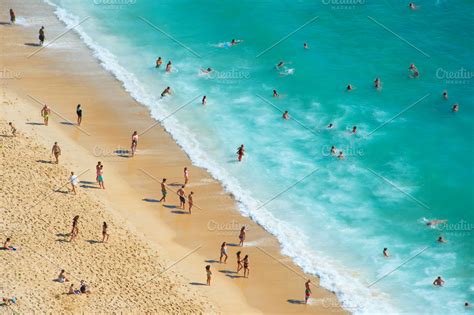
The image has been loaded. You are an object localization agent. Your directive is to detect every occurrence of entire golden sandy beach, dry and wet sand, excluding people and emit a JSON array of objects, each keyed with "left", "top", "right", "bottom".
[{"left": 0, "top": 0, "right": 345, "bottom": 314}]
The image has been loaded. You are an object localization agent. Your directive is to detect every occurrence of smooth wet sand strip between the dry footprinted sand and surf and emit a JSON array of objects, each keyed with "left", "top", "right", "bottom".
[{"left": 2, "top": 1, "right": 344, "bottom": 313}]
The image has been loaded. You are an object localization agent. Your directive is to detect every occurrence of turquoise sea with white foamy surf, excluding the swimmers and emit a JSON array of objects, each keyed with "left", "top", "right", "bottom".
[{"left": 39, "top": 0, "right": 474, "bottom": 314}]
